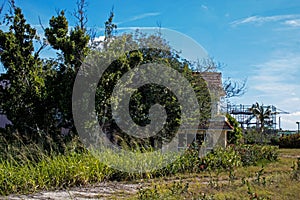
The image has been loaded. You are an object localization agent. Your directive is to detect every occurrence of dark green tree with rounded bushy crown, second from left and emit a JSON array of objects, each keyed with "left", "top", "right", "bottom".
[{"left": 45, "top": 3, "right": 90, "bottom": 132}]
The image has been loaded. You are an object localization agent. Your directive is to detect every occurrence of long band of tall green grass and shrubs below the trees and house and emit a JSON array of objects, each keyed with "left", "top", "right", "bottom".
[{"left": 0, "top": 130, "right": 276, "bottom": 195}]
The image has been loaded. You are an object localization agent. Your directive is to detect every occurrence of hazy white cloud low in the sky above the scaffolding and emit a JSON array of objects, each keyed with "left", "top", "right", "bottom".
[{"left": 248, "top": 52, "right": 300, "bottom": 130}]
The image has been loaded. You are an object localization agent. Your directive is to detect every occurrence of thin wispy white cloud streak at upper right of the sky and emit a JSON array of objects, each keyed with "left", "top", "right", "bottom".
[{"left": 230, "top": 14, "right": 300, "bottom": 26}]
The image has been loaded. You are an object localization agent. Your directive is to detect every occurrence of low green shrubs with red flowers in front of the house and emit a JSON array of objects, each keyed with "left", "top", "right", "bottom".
[{"left": 160, "top": 144, "right": 278, "bottom": 174}]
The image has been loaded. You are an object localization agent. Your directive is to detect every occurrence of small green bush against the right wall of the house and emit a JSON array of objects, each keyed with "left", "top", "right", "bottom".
[{"left": 226, "top": 113, "right": 243, "bottom": 144}]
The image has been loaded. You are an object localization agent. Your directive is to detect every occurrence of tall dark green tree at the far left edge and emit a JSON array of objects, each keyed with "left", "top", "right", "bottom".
[{"left": 0, "top": 1, "right": 47, "bottom": 134}]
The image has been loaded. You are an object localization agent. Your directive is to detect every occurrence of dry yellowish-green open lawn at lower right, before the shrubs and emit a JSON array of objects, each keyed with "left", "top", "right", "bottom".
[{"left": 129, "top": 149, "right": 300, "bottom": 200}]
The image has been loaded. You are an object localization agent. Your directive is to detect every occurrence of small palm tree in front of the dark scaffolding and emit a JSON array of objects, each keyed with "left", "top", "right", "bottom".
[{"left": 250, "top": 102, "right": 272, "bottom": 134}]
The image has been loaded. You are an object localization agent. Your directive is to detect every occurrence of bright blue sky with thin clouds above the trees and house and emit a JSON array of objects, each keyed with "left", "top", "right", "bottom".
[{"left": 0, "top": 0, "right": 300, "bottom": 130}]
